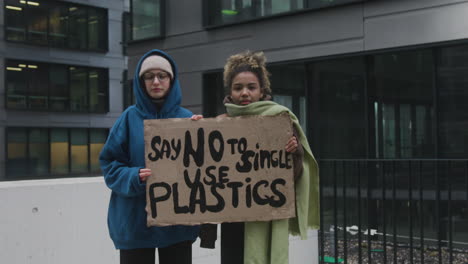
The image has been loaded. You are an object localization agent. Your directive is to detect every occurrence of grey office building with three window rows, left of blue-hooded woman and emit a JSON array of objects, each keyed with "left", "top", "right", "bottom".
[{"left": 0, "top": 0, "right": 129, "bottom": 181}]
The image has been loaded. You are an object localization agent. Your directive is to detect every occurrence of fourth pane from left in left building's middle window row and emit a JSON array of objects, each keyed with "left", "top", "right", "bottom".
[{"left": 69, "top": 66, "right": 88, "bottom": 112}]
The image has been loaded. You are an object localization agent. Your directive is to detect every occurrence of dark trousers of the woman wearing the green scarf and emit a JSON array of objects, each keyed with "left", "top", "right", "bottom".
[{"left": 221, "top": 223, "right": 244, "bottom": 264}]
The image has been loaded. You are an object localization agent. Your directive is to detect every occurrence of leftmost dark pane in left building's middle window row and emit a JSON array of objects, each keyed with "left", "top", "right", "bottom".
[{"left": 5, "top": 61, "right": 29, "bottom": 109}]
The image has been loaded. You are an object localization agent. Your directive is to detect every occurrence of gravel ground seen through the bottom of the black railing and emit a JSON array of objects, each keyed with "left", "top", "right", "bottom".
[{"left": 324, "top": 239, "right": 468, "bottom": 264}]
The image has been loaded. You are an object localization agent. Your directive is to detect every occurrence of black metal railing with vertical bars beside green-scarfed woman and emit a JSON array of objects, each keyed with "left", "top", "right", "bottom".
[{"left": 319, "top": 159, "right": 468, "bottom": 263}]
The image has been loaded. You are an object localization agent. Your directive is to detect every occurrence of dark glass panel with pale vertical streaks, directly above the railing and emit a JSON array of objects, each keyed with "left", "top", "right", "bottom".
[{"left": 369, "top": 50, "right": 435, "bottom": 158}]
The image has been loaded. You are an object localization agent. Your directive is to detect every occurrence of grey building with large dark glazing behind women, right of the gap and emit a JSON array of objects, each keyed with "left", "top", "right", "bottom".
[{"left": 128, "top": 0, "right": 468, "bottom": 263}]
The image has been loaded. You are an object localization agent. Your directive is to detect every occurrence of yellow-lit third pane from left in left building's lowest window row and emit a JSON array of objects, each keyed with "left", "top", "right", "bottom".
[{"left": 50, "top": 128, "right": 70, "bottom": 174}]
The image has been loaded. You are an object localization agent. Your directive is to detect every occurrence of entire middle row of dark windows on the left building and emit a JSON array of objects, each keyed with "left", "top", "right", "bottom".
[{"left": 5, "top": 60, "right": 109, "bottom": 113}]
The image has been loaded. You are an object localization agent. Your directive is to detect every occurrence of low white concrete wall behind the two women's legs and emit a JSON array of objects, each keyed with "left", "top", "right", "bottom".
[{"left": 0, "top": 177, "right": 318, "bottom": 264}]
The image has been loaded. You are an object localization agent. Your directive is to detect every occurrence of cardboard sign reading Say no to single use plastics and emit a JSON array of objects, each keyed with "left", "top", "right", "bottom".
[{"left": 144, "top": 114, "right": 295, "bottom": 226}]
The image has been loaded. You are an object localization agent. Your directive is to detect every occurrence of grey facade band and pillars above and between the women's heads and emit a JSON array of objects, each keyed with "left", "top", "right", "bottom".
[{"left": 129, "top": 0, "right": 468, "bottom": 112}]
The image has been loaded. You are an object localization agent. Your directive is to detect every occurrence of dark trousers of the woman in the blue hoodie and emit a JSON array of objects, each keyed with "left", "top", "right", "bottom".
[{"left": 120, "top": 241, "right": 192, "bottom": 264}]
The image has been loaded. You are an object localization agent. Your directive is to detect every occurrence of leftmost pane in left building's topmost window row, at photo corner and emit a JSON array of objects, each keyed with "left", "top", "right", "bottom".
[{"left": 5, "top": 0, "right": 26, "bottom": 41}]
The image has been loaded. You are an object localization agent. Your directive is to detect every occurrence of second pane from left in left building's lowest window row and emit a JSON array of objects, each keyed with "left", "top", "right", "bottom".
[{"left": 29, "top": 128, "right": 49, "bottom": 175}]
